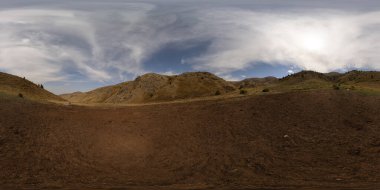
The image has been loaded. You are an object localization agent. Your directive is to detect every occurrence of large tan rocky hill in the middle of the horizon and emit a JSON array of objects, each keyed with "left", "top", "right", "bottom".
[{"left": 61, "top": 72, "right": 236, "bottom": 103}]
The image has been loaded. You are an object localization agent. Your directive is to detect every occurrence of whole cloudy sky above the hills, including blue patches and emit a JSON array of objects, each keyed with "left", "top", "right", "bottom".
[{"left": 0, "top": 0, "right": 380, "bottom": 94}]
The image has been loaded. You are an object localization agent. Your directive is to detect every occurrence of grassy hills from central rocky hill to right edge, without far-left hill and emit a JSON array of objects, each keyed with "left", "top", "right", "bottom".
[{"left": 61, "top": 71, "right": 380, "bottom": 104}]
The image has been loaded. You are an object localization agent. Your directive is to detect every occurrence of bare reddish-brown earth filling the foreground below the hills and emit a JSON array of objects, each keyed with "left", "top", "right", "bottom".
[{"left": 0, "top": 90, "right": 380, "bottom": 189}]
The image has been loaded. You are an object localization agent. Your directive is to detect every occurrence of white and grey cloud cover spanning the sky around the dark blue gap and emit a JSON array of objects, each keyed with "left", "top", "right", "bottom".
[{"left": 0, "top": 1, "right": 380, "bottom": 90}]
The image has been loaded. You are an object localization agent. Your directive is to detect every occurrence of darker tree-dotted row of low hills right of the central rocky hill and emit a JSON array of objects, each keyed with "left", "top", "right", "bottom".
[{"left": 236, "top": 71, "right": 380, "bottom": 95}]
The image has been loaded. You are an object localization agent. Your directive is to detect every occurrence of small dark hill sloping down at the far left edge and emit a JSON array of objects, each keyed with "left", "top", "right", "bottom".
[{"left": 0, "top": 72, "right": 64, "bottom": 101}]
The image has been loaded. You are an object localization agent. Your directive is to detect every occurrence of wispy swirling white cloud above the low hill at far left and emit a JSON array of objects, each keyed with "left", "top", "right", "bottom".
[{"left": 0, "top": 10, "right": 110, "bottom": 83}]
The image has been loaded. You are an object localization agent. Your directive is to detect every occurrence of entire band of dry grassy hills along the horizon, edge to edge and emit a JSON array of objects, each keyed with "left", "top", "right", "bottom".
[{"left": 0, "top": 70, "right": 380, "bottom": 104}]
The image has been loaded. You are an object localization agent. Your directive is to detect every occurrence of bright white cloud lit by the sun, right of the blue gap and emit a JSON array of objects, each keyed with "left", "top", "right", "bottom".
[{"left": 193, "top": 9, "right": 380, "bottom": 73}]
